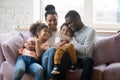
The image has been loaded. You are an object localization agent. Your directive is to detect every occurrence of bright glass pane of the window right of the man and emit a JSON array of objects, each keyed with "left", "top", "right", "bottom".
[{"left": 93, "top": 0, "right": 120, "bottom": 24}]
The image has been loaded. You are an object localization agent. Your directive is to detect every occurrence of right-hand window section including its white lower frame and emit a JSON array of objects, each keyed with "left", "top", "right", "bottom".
[{"left": 92, "top": 0, "right": 120, "bottom": 30}]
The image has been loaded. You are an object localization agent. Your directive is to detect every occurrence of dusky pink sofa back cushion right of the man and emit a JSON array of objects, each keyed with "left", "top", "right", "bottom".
[{"left": 93, "top": 33, "right": 120, "bottom": 65}]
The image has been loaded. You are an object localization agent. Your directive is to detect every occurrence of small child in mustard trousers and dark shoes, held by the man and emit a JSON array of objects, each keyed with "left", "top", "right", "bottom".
[{"left": 51, "top": 23, "right": 77, "bottom": 74}]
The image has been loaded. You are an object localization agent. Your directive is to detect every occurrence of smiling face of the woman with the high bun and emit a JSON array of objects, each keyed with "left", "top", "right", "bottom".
[{"left": 45, "top": 14, "right": 58, "bottom": 31}]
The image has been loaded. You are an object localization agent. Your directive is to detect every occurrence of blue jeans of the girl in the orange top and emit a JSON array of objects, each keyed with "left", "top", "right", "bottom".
[{"left": 13, "top": 55, "right": 44, "bottom": 80}]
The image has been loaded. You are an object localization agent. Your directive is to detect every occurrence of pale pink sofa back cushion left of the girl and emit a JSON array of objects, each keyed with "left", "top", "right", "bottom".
[{"left": 0, "top": 32, "right": 31, "bottom": 64}]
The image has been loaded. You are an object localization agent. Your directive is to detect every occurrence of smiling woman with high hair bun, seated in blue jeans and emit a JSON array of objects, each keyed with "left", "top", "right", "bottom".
[{"left": 24, "top": 4, "right": 59, "bottom": 80}]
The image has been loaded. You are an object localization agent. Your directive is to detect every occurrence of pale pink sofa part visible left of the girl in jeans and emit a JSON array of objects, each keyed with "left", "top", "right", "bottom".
[{"left": 0, "top": 32, "right": 34, "bottom": 80}]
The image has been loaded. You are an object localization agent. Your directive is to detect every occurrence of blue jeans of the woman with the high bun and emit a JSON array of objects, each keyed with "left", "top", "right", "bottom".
[{"left": 41, "top": 47, "right": 56, "bottom": 78}]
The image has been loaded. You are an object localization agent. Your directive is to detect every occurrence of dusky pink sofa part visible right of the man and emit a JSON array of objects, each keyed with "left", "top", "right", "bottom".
[{"left": 67, "top": 33, "right": 120, "bottom": 80}]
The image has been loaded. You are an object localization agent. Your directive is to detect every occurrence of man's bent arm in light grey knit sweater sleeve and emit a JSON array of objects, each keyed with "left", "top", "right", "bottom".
[{"left": 71, "top": 29, "right": 95, "bottom": 54}]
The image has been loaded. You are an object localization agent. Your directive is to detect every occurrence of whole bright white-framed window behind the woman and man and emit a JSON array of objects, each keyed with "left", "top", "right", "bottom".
[{"left": 37, "top": 0, "right": 120, "bottom": 31}]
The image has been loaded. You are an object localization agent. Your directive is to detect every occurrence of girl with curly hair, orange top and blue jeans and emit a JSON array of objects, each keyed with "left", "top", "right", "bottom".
[{"left": 13, "top": 22, "right": 50, "bottom": 80}]
